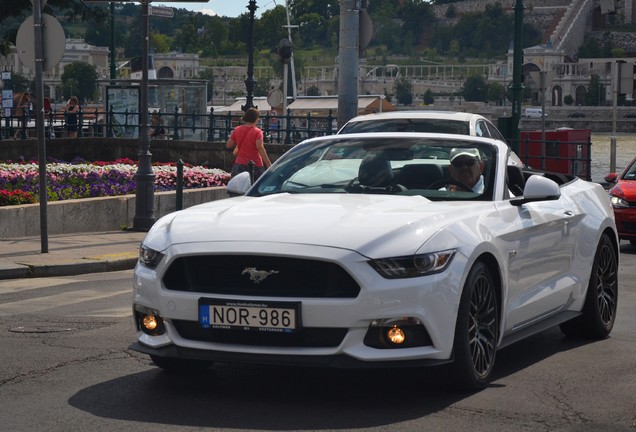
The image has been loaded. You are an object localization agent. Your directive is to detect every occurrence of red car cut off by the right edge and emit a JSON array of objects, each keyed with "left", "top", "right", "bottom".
[{"left": 605, "top": 158, "right": 636, "bottom": 244}]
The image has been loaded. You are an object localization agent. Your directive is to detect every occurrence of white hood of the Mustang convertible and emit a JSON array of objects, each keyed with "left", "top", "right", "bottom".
[{"left": 144, "top": 194, "right": 491, "bottom": 256}]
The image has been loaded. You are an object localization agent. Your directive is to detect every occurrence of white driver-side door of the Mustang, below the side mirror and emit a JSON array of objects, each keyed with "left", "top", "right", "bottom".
[{"left": 498, "top": 189, "right": 578, "bottom": 335}]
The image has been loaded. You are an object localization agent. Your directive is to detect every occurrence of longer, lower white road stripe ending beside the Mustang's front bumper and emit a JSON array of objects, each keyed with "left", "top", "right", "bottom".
[{"left": 0, "top": 289, "right": 131, "bottom": 316}]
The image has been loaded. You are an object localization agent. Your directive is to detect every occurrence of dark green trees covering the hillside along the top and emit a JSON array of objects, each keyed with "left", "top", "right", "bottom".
[{"left": 0, "top": 0, "right": 540, "bottom": 65}]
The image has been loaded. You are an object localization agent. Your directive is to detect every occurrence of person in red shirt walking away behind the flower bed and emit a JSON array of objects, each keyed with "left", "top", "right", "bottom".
[{"left": 225, "top": 108, "right": 272, "bottom": 180}]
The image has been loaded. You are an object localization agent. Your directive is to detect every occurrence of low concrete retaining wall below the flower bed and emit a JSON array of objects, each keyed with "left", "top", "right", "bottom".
[{"left": 0, "top": 187, "right": 228, "bottom": 239}]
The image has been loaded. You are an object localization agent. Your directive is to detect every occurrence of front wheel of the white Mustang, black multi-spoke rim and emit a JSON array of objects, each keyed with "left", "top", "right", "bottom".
[{"left": 451, "top": 262, "right": 500, "bottom": 390}]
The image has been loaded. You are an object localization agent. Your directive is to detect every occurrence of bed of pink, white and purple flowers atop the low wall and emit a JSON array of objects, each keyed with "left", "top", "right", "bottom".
[{"left": 0, "top": 159, "right": 230, "bottom": 206}]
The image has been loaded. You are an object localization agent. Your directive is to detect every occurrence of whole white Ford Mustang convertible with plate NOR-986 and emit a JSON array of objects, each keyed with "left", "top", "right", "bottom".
[{"left": 131, "top": 133, "right": 619, "bottom": 389}]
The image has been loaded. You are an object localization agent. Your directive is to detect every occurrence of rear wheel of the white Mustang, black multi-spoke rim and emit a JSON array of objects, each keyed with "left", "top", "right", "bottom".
[{"left": 560, "top": 234, "right": 618, "bottom": 339}]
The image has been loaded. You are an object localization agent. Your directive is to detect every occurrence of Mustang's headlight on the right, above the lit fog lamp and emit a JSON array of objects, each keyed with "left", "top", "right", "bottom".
[{"left": 369, "top": 249, "right": 455, "bottom": 279}]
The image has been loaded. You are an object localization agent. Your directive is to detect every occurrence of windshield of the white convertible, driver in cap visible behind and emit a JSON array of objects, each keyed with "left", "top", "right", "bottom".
[{"left": 248, "top": 135, "right": 496, "bottom": 200}]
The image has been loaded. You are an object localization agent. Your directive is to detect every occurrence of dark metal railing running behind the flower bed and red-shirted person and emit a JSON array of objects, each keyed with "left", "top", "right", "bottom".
[{"left": 0, "top": 107, "right": 337, "bottom": 144}]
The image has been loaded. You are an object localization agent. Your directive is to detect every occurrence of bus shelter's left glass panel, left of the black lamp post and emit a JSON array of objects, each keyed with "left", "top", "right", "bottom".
[{"left": 106, "top": 86, "right": 141, "bottom": 138}]
